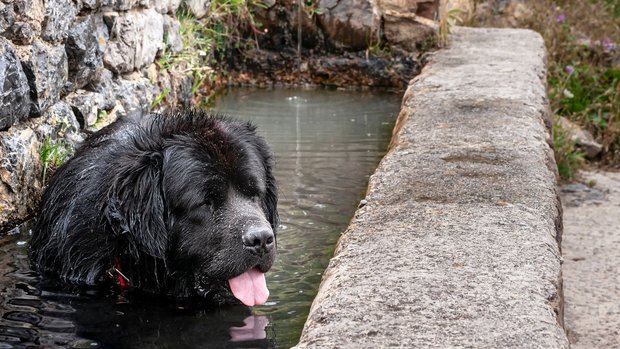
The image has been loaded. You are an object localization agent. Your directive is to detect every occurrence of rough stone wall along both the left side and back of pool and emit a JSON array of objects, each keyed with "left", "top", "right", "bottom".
[{"left": 0, "top": 0, "right": 440, "bottom": 232}]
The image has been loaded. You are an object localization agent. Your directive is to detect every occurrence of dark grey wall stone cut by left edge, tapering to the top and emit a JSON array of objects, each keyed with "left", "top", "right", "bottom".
[{"left": 0, "top": 37, "right": 33, "bottom": 130}]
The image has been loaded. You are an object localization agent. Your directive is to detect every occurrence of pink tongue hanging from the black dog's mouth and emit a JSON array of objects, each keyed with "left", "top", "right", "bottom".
[{"left": 228, "top": 268, "right": 269, "bottom": 307}]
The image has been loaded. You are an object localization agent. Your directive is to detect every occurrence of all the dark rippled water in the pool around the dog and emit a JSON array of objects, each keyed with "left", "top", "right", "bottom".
[{"left": 0, "top": 89, "right": 400, "bottom": 348}]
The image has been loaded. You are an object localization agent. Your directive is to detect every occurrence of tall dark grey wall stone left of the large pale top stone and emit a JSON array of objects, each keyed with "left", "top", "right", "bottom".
[{"left": 65, "top": 15, "right": 109, "bottom": 88}]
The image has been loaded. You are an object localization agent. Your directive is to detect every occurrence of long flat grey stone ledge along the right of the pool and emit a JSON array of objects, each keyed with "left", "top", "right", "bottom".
[{"left": 297, "top": 28, "right": 568, "bottom": 348}]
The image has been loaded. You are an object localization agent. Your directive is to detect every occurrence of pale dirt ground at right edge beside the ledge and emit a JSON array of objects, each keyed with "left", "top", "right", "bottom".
[{"left": 561, "top": 171, "right": 620, "bottom": 349}]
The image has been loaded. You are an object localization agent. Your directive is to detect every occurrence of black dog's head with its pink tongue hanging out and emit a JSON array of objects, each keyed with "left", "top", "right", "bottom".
[{"left": 104, "top": 115, "right": 278, "bottom": 305}]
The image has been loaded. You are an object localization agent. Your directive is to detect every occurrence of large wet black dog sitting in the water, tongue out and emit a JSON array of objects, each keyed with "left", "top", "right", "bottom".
[{"left": 30, "top": 112, "right": 278, "bottom": 306}]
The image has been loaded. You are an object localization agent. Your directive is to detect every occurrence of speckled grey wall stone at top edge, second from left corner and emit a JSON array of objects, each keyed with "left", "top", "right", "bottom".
[{"left": 41, "top": 0, "right": 79, "bottom": 43}]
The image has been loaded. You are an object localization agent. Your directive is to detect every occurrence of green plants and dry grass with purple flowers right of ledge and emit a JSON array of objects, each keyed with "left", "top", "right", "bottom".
[{"left": 478, "top": 0, "right": 620, "bottom": 179}]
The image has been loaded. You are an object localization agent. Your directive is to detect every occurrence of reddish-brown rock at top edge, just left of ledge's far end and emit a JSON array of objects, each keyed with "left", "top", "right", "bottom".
[{"left": 377, "top": 0, "right": 439, "bottom": 52}]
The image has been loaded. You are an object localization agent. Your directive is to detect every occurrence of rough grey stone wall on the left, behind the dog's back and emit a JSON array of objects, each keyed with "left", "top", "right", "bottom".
[{"left": 0, "top": 0, "right": 209, "bottom": 231}]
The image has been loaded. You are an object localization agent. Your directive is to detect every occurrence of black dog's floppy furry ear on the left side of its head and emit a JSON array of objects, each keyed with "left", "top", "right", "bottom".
[{"left": 104, "top": 152, "right": 168, "bottom": 258}]
